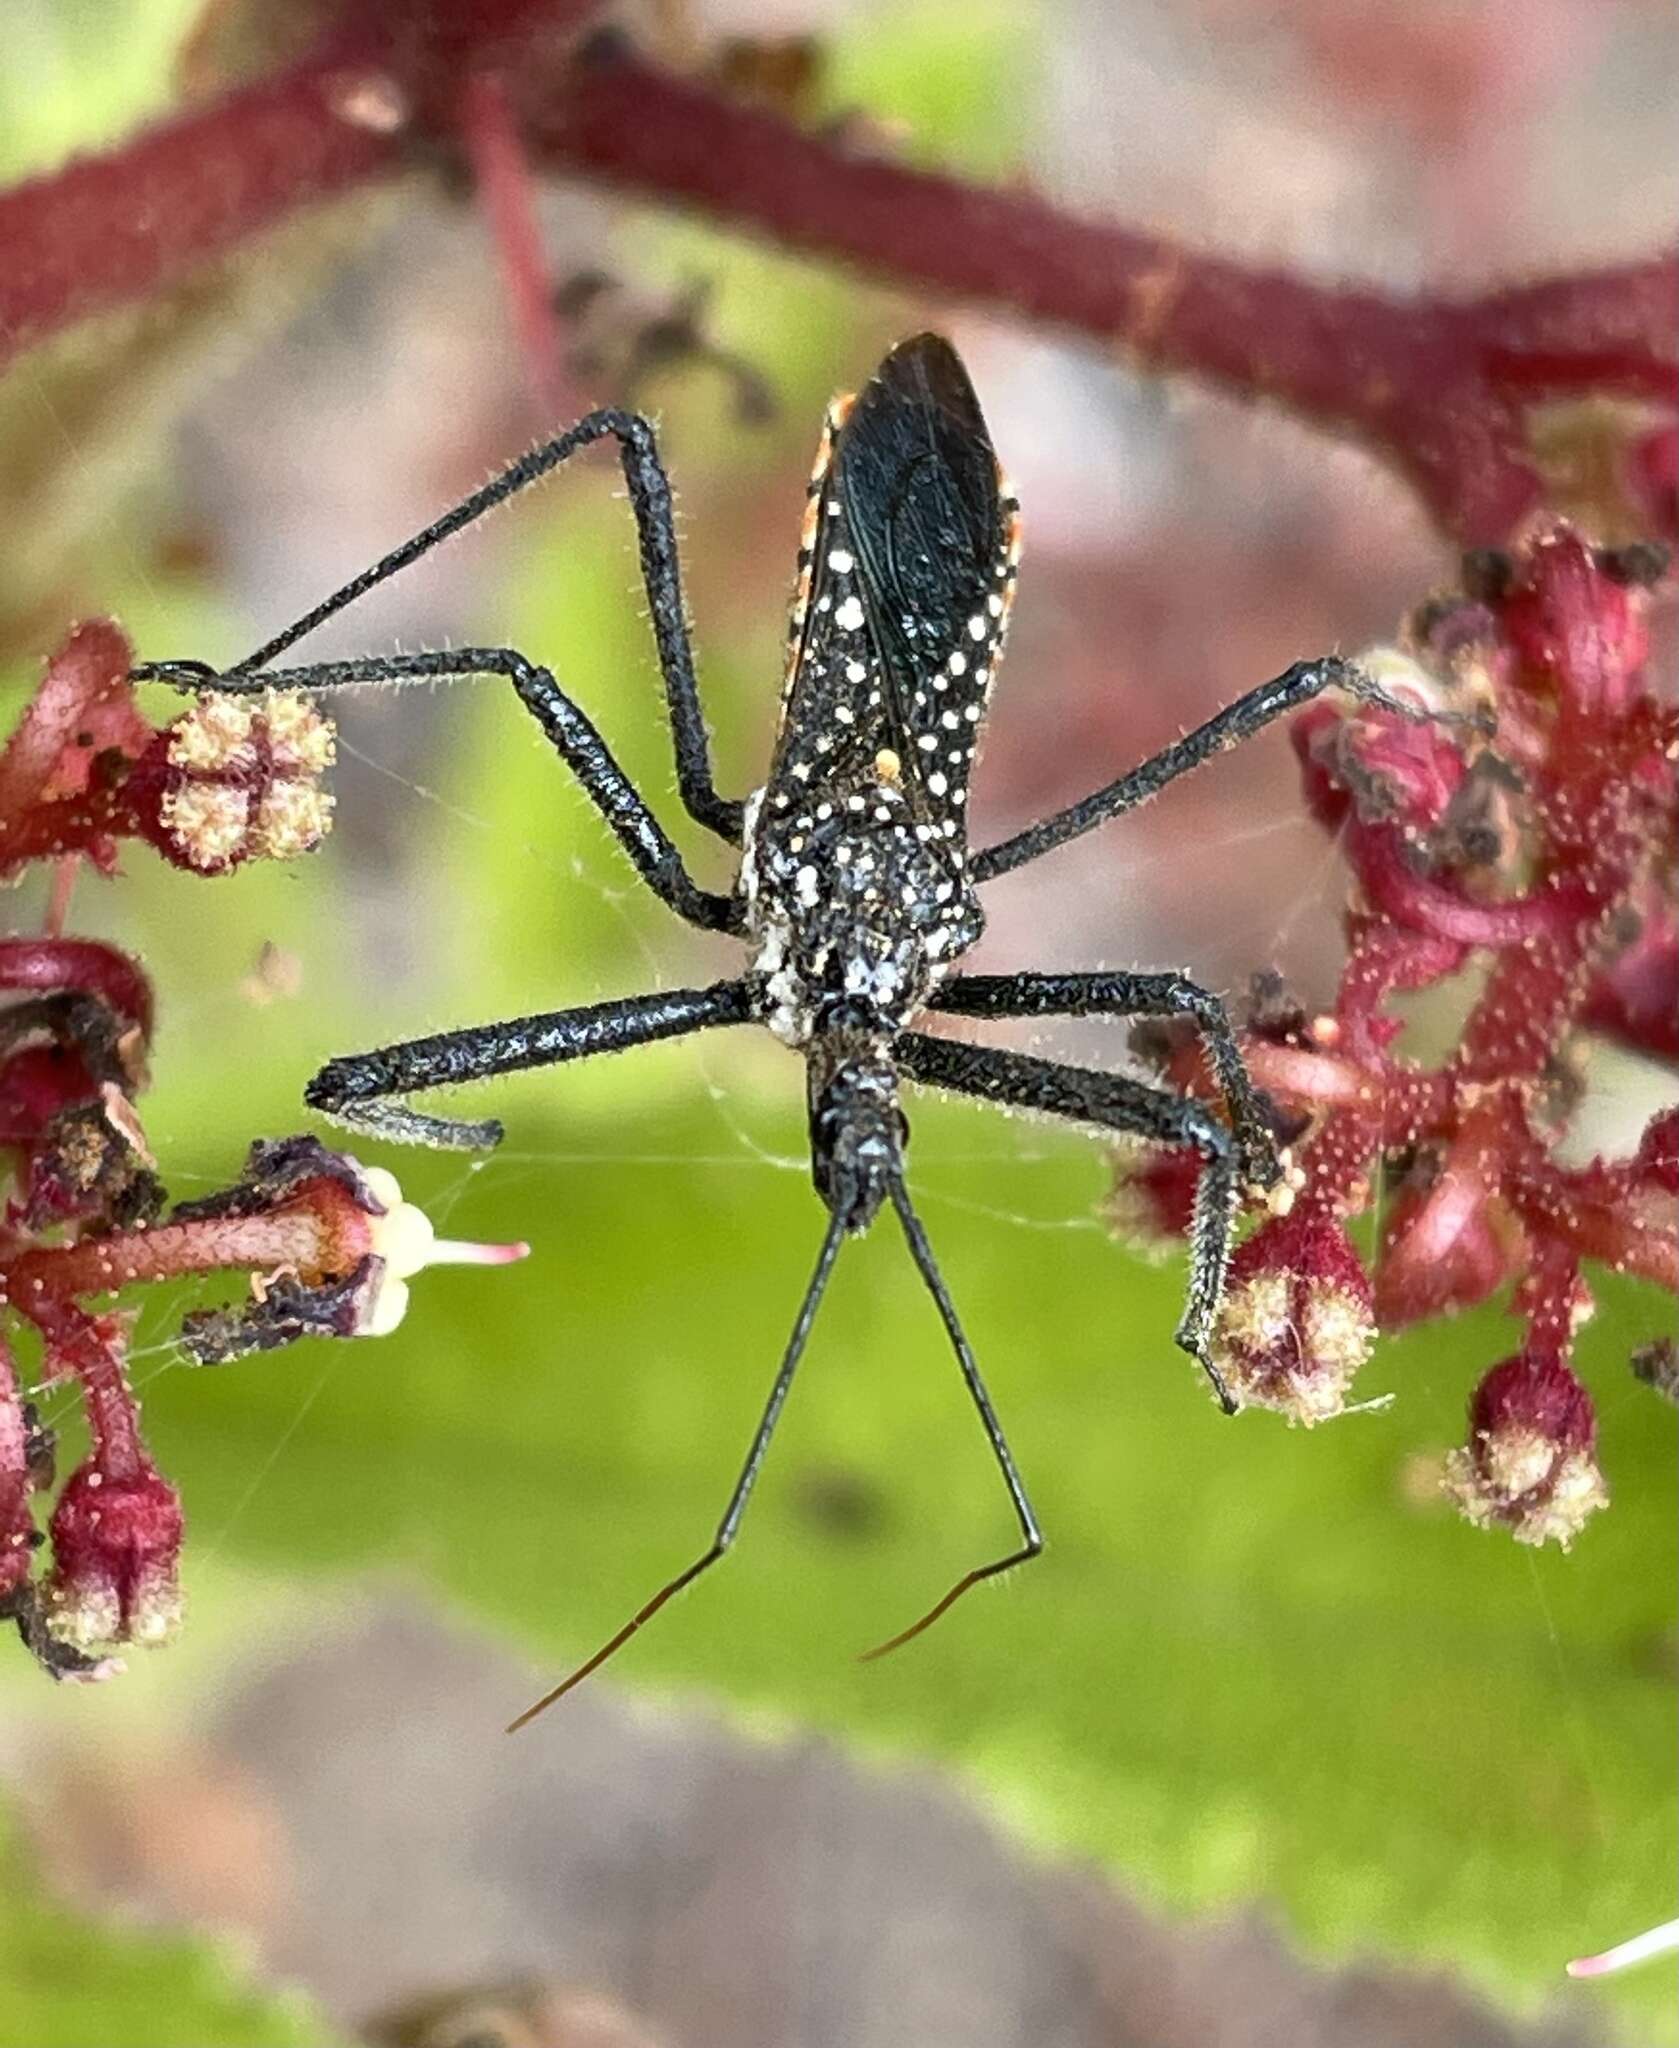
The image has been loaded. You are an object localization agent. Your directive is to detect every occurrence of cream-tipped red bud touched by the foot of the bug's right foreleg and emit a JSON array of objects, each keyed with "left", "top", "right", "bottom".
[{"left": 1212, "top": 1210, "right": 1376, "bottom": 1425}]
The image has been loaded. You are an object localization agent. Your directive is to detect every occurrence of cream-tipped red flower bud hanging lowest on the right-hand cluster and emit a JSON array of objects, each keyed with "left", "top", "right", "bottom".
[{"left": 1444, "top": 1354, "right": 1609, "bottom": 1550}]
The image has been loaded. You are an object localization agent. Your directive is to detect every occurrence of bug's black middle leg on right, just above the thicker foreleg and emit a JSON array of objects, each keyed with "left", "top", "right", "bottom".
[{"left": 928, "top": 971, "right": 1280, "bottom": 1188}]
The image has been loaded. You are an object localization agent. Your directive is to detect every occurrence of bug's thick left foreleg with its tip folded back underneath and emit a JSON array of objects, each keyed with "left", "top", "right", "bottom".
[{"left": 303, "top": 981, "right": 756, "bottom": 1151}]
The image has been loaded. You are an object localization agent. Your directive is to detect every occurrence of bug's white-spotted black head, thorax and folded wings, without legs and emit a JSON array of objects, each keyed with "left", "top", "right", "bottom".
[{"left": 741, "top": 338, "right": 1020, "bottom": 1229}]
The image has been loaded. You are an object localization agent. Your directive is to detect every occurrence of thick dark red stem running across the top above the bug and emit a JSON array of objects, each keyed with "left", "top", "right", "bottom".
[{"left": 0, "top": 18, "right": 1679, "bottom": 543}]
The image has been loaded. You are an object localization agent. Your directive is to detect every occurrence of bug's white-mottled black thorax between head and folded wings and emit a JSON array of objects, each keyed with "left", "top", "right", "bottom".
[{"left": 741, "top": 782, "right": 985, "bottom": 1047}]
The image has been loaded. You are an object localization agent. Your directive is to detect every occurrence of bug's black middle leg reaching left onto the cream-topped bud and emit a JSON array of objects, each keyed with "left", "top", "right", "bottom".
[{"left": 133, "top": 647, "right": 739, "bottom": 932}]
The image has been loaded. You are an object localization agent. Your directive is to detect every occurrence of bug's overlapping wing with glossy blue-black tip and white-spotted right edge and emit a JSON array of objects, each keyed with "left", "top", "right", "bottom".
[{"left": 835, "top": 334, "right": 1018, "bottom": 821}]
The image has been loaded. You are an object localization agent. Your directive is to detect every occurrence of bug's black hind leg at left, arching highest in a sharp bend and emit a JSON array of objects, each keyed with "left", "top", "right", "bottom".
[{"left": 147, "top": 406, "right": 743, "bottom": 846}]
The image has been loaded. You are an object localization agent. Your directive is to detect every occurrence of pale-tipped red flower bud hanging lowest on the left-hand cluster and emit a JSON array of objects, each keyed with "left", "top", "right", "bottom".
[{"left": 43, "top": 1458, "right": 182, "bottom": 1651}]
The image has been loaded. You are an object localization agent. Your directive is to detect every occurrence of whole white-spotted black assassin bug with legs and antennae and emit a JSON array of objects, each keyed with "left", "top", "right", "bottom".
[{"left": 135, "top": 334, "right": 1415, "bottom": 1726}]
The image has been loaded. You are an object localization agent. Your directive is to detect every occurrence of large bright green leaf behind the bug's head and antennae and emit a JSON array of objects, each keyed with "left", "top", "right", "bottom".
[{"left": 101, "top": 1097, "right": 1675, "bottom": 2042}]
